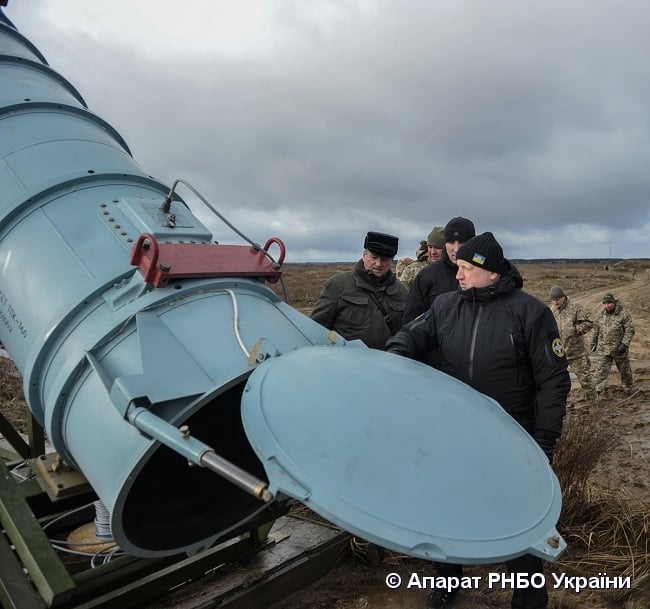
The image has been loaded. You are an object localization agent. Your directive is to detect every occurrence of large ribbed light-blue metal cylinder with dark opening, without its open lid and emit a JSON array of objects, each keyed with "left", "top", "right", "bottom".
[{"left": 0, "top": 10, "right": 330, "bottom": 556}]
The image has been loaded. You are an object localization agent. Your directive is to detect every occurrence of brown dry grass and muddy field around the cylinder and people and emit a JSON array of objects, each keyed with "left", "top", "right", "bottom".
[{"left": 0, "top": 260, "right": 650, "bottom": 609}]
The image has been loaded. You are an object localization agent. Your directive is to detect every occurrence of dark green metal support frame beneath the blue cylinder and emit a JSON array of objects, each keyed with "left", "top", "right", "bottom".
[{"left": 0, "top": 417, "right": 288, "bottom": 609}]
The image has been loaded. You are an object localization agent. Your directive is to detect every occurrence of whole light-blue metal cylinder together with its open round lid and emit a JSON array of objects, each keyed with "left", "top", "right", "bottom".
[{"left": 0, "top": 12, "right": 563, "bottom": 562}]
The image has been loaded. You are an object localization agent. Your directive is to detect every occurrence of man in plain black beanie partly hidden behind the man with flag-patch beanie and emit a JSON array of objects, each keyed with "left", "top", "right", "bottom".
[{"left": 402, "top": 216, "right": 476, "bottom": 324}]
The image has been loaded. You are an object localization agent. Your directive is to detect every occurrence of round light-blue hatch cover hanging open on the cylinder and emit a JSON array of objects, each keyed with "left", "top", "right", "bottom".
[{"left": 242, "top": 344, "right": 566, "bottom": 563}]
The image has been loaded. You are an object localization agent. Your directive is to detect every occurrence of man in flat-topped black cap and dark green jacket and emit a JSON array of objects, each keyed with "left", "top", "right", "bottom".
[{"left": 311, "top": 231, "right": 408, "bottom": 349}]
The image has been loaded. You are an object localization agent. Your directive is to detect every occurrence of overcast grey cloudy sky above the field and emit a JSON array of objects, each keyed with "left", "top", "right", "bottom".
[{"left": 4, "top": 0, "right": 650, "bottom": 262}]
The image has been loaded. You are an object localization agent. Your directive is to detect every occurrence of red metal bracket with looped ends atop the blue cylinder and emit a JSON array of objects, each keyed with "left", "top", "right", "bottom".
[{"left": 131, "top": 233, "right": 285, "bottom": 288}]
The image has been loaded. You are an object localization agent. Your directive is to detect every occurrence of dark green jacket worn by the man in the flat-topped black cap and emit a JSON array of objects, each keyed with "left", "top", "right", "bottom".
[{"left": 311, "top": 260, "right": 408, "bottom": 349}]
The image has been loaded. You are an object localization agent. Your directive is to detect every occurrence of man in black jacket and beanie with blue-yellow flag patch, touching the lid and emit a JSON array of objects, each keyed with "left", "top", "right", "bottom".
[{"left": 386, "top": 233, "right": 571, "bottom": 609}]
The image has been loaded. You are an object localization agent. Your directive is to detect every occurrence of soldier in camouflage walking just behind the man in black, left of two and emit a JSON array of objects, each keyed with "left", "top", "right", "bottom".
[{"left": 550, "top": 285, "right": 597, "bottom": 408}]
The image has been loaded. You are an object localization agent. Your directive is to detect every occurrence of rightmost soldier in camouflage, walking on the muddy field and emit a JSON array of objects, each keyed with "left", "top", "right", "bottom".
[{"left": 591, "top": 293, "right": 634, "bottom": 394}]
